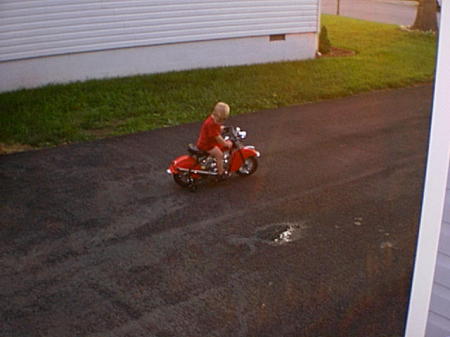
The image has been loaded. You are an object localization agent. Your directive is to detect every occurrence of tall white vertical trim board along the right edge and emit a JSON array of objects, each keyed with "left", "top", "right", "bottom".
[{"left": 405, "top": 1, "right": 450, "bottom": 337}]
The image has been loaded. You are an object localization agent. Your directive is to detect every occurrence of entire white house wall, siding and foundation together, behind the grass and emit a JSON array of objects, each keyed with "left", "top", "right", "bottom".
[{"left": 0, "top": 0, "right": 319, "bottom": 91}]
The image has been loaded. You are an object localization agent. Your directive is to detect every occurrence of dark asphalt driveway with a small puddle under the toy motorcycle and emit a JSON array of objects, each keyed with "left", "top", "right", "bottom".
[{"left": 0, "top": 85, "right": 432, "bottom": 337}]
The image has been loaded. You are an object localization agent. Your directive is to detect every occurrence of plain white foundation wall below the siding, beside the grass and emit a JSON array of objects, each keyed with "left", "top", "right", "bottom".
[{"left": 0, "top": 33, "right": 316, "bottom": 91}]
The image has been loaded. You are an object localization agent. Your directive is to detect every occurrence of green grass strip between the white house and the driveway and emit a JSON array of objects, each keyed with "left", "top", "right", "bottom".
[{"left": 0, "top": 15, "right": 436, "bottom": 147}]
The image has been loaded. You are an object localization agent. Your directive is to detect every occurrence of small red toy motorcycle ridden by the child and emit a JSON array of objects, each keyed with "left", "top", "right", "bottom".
[{"left": 166, "top": 126, "right": 260, "bottom": 191}]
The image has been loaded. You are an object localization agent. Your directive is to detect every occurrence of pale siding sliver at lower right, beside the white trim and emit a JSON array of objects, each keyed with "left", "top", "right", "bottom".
[{"left": 426, "top": 171, "right": 450, "bottom": 337}]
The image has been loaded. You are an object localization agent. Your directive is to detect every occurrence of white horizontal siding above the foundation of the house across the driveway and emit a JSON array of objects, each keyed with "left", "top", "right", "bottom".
[{"left": 0, "top": 0, "right": 319, "bottom": 61}]
